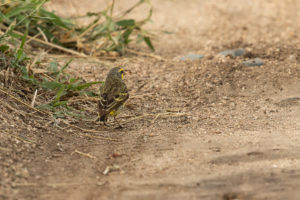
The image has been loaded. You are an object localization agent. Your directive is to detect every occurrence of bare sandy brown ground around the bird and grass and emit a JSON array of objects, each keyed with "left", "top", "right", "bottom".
[{"left": 0, "top": 0, "right": 300, "bottom": 200}]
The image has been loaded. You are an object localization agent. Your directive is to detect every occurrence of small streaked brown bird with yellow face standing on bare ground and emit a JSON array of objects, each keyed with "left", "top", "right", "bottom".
[{"left": 96, "top": 67, "right": 129, "bottom": 127}]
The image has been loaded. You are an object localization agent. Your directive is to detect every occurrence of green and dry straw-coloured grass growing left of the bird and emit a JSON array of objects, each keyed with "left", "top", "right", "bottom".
[{"left": 0, "top": 0, "right": 154, "bottom": 118}]
